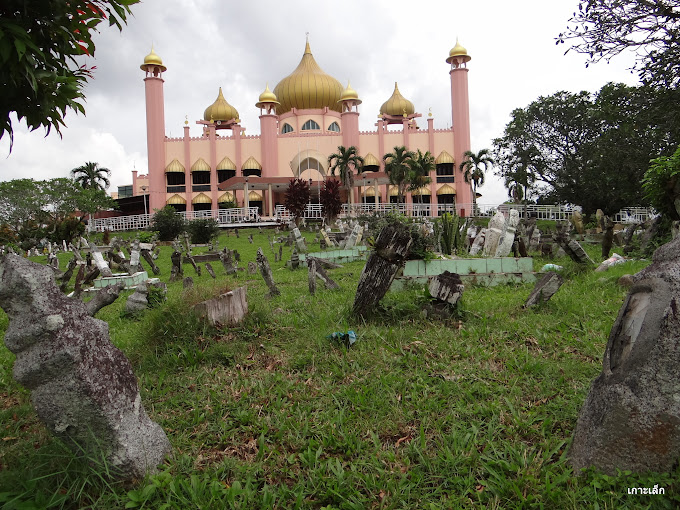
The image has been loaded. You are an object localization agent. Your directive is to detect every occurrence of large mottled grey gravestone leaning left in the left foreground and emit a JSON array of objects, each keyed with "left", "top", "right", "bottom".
[{"left": 0, "top": 255, "right": 170, "bottom": 479}]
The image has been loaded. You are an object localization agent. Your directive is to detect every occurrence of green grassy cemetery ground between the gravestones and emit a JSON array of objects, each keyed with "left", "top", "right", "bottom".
[{"left": 0, "top": 229, "right": 680, "bottom": 509}]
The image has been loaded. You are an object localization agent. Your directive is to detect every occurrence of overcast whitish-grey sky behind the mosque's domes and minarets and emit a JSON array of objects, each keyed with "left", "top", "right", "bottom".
[{"left": 0, "top": 0, "right": 638, "bottom": 204}]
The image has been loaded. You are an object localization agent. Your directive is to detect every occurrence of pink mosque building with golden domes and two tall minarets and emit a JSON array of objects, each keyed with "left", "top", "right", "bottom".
[{"left": 132, "top": 37, "right": 472, "bottom": 216}]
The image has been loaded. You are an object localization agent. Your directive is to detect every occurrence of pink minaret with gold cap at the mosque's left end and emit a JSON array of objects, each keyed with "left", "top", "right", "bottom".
[{"left": 139, "top": 46, "right": 167, "bottom": 212}]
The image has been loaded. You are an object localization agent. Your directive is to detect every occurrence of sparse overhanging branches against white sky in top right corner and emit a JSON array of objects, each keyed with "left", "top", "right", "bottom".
[{"left": 557, "top": 0, "right": 680, "bottom": 88}]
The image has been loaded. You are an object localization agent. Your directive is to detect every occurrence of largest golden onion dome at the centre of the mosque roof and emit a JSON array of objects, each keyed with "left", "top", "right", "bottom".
[{"left": 274, "top": 41, "right": 343, "bottom": 115}]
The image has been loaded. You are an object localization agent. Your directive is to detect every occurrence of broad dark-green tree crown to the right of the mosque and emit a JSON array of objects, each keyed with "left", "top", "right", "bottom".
[{"left": 493, "top": 83, "right": 680, "bottom": 214}]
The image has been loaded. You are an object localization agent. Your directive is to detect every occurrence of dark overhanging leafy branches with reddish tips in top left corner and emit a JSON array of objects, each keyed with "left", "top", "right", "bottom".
[{"left": 0, "top": 0, "right": 139, "bottom": 150}]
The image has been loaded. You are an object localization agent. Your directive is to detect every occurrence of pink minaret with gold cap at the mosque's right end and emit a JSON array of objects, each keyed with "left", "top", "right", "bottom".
[{"left": 446, "top": 39, "right": 472, "bottom": 216}]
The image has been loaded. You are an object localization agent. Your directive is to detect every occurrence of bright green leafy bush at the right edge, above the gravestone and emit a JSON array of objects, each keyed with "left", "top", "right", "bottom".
[{"left": 642, "top": 146, "right": 680, "bottom": 220}]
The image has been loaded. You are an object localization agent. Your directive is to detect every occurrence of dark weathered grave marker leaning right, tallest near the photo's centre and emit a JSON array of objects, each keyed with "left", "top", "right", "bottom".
[{"left": 352, "top": 225, "right": 413, "bottom": 315}]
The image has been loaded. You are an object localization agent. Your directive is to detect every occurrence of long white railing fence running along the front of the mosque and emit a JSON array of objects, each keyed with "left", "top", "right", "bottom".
[{"left": 89, "top": 203, "right": 657, "bottom": 232}]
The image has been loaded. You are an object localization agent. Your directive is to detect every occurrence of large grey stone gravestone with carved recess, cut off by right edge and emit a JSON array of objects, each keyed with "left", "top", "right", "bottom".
[{"left": 569, "top": 238, "right": 680, "bottom": 474}]
